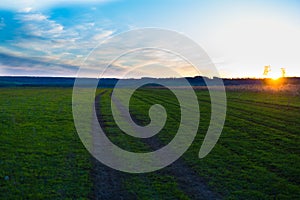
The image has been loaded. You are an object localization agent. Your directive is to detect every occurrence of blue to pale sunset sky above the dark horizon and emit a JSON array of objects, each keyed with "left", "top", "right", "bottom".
[{"left": 0, "top": 0, "right": 300, "bottom": 78}]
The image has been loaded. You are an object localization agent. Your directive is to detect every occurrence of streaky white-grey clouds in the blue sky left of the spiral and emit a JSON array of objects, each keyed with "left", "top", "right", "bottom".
[{"left": 0, "top": 9, "right": 115, "bottom": 76}]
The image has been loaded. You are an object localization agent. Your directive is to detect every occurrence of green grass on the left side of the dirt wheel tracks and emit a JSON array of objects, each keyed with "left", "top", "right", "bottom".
[{"left": 0, "top": 88, "right": 92, "bottom": 199}]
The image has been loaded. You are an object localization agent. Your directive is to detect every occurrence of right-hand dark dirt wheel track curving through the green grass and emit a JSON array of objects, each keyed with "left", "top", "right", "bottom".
[{"left": 112, "top": 91, "right": 221, "bottom": 199}]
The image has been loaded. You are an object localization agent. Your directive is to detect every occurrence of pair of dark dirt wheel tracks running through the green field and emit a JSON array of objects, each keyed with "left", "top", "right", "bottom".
[{"left": 92, "top": 93, "right": 221, "bottom": 200}]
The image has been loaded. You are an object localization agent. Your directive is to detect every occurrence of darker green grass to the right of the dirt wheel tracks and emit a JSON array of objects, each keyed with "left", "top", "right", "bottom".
[{"left": 99, "top": 90, "right": 300, "bottom": 199}]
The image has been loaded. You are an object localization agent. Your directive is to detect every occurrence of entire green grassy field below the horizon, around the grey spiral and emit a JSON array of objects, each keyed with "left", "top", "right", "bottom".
[{"left": 0, "top": 88, "right": 300, "bottom": 199}]
